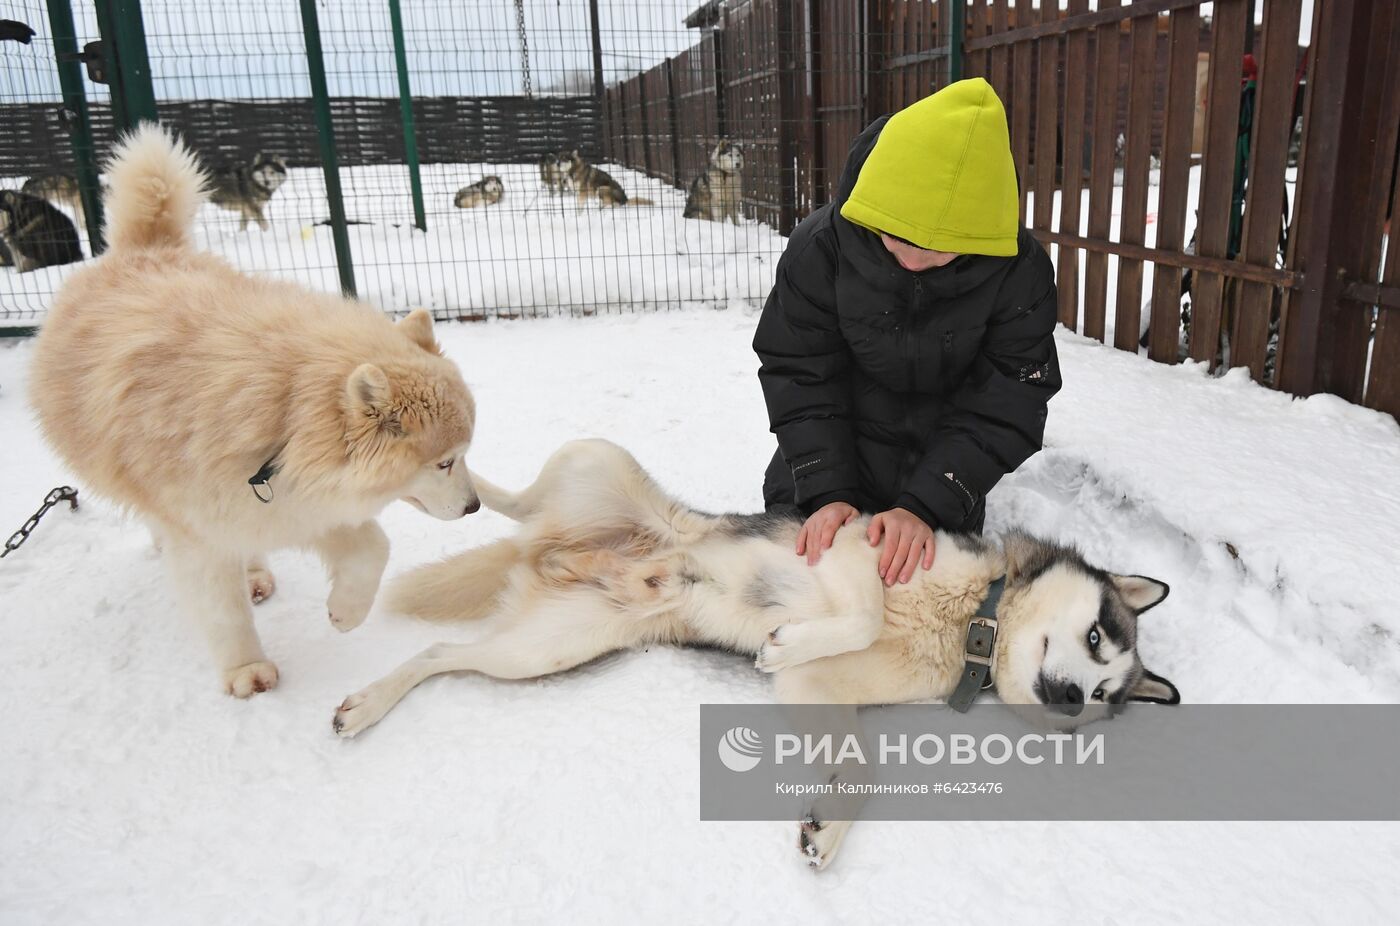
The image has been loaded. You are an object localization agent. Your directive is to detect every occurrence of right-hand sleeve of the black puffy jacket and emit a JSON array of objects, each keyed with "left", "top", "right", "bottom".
[{"left": 896, "top": 247, "right": 1061, "bottom": 531}]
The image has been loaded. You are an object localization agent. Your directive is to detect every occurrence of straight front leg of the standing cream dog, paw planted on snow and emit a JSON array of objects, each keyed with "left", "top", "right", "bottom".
[{"left": 161, "top": 537, "right": 277, "bottom": 698}]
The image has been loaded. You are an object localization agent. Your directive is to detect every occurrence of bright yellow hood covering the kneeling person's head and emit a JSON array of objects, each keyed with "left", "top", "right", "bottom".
[{"left": 839, "top": 77, "right": 1019, "bottom": 258}]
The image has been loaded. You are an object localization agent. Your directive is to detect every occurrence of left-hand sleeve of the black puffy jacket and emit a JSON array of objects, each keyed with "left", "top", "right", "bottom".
[{"left": 753, "top": 228, "right": 860, "bottom": 511}]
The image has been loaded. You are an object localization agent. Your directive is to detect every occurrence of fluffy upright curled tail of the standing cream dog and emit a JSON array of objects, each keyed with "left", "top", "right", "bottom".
[{"left": 106, "top": 123, "right": 206, "bottom": 251}]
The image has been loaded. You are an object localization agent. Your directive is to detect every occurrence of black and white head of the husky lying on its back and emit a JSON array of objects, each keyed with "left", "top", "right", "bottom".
[{"left": 993, "top": 532, "right": 1182, "bottom": 726}]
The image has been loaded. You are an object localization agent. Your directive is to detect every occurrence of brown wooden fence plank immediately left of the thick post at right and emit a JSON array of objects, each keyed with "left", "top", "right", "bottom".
[{"left": 1231, "top": 0, "right": 1302, "bottom": 382}]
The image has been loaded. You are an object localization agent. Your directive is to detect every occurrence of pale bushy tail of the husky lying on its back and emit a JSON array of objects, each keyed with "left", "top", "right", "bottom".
[{"left": 386, "top": 538, "right": 522, "bottom": 622}]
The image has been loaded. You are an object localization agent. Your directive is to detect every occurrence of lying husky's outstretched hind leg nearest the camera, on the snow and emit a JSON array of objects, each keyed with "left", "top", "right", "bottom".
[{"left": 332, "top": 593, "right": 654, "bottom": 737}]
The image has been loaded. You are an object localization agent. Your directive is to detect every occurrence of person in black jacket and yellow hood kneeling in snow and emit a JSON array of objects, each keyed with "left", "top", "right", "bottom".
[{"left": 753, "top": 78, "right": 1060, "bottom": 586}]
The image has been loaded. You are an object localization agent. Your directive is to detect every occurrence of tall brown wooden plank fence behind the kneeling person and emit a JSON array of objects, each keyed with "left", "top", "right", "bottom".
[{"left": 602, "top": 0, "right": 1400, "bottom": 413}]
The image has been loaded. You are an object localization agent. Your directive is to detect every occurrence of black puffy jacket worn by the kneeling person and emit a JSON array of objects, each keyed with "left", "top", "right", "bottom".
[{"left": 753, "top": 119, "right": 1060, "bottom": 531}]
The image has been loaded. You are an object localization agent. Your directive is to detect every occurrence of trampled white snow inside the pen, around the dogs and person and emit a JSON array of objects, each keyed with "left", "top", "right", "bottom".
[{"left": 0, "top": 308, "right": 1400, "bottom": 925}]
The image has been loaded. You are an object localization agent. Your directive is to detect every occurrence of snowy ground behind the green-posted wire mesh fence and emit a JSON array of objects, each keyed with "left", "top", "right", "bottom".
[{"left": 0, "top": 164, "right": 787, "bottom": 325}]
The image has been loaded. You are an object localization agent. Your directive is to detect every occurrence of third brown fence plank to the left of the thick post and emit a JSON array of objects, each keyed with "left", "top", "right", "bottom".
[{"left": 1148, "top": 8, "right": 1200, "bottom": 363}]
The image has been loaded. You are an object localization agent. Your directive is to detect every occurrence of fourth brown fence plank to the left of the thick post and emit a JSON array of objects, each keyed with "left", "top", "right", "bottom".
[{"left": 1113, "top": 6, "right": 1156, "bottom": 352}]
